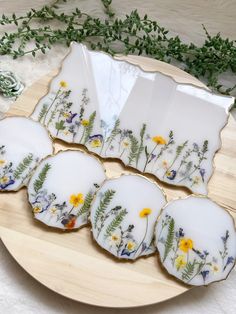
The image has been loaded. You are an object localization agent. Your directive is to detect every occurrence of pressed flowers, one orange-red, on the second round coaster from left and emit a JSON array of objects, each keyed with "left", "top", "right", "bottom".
[{"left": 28, "top": 163, "right": 99, "bottom": 229}]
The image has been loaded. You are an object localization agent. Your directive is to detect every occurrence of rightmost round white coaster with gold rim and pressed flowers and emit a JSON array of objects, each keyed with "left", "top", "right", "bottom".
[{"left": 155, "top": 196, "right": 236, "bottom": 286}]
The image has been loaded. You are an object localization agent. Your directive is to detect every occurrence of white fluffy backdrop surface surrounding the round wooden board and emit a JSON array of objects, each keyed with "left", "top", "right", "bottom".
[{"left": 0, "top": 0, "right": 236, "bottom": 314}]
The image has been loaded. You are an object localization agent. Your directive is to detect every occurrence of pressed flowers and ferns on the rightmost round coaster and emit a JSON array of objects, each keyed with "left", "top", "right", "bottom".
[{"left": 157, "top": 214, "right": 235, "bottom": 285}]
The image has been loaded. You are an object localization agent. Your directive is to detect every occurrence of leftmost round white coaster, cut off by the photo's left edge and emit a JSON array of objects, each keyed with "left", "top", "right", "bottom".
[{"left": 0, "top": 117, "right": 53, "bottom": 191}]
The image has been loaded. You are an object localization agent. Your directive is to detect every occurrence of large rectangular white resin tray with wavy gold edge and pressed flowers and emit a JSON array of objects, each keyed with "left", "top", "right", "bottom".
[{"left": 32, "top": 43, "right": 233, "bottom": 194}]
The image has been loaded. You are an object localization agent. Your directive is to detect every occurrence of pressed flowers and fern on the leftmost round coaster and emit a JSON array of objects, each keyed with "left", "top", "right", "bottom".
[{"left": 0, "top": 145, "right": 39, "bottom": 191}]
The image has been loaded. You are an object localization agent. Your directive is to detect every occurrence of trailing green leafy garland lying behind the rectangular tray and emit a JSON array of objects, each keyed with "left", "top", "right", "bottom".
[{"left": 0, "top": 0, "right": 236, "bottom": 100}]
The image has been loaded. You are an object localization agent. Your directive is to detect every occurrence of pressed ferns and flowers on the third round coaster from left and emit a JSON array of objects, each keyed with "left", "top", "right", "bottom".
[{"left": 91, "top": 189, "right": 156, "bottom": 259}]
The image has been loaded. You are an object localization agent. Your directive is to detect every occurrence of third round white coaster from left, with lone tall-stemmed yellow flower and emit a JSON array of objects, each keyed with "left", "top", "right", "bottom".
[{"left": 91, "top": 175, "right": 166, "bottom": 260}]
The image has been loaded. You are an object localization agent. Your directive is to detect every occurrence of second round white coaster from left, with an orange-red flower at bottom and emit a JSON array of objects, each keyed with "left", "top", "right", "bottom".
[{"left": 28, "top": 151, "right": 105, "bottom": 229}]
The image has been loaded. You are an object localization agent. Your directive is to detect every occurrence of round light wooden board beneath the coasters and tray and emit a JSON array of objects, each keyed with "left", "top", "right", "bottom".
[{"left": 0, "top": 56, "right": 236, "bottom": 308}]
